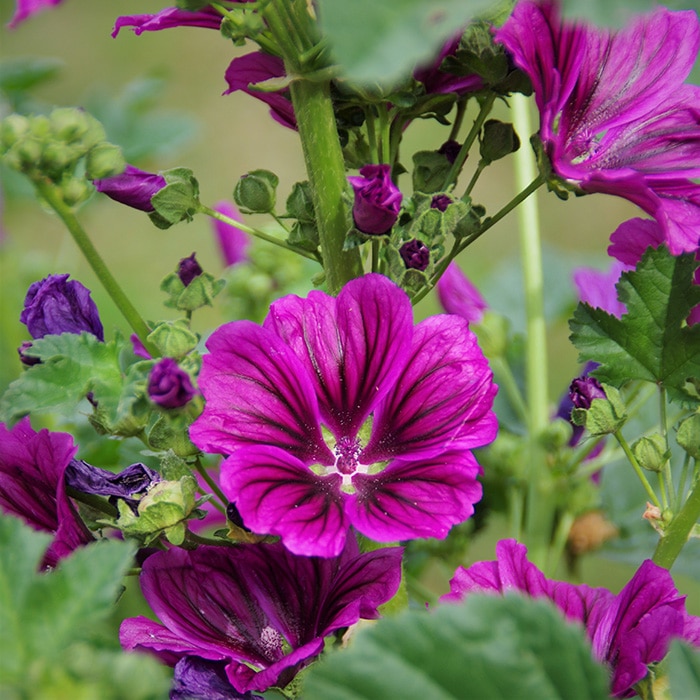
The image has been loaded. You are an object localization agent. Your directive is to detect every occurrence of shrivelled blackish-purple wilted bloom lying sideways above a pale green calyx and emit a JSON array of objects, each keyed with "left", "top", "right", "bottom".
[{"left": 65, "top": 459, "right": 160, "bottom": 511}]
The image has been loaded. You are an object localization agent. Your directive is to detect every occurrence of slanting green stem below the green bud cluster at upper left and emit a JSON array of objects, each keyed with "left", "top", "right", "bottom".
[{"left": 34, "top": 180, "right": 160, "bottom": 357}]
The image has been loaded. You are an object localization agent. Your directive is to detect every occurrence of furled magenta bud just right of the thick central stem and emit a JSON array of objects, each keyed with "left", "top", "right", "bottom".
[{"left": 348, "top": 165, "right": 402, "bottom": 235}]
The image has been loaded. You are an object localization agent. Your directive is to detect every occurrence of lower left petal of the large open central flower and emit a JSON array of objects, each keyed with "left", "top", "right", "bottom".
[{"left": 221, "top": 446, "right": 348, "bottom": 557}]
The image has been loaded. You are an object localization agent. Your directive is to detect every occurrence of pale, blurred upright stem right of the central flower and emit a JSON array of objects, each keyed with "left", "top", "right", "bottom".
[{"left": 512, "top": 95, "right": 555, "bottom": 569}]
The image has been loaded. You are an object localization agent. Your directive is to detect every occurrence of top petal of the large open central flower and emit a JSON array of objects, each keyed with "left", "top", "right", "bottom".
[{"left": 265, "top": 274, "right": 413, "bottom": 437}]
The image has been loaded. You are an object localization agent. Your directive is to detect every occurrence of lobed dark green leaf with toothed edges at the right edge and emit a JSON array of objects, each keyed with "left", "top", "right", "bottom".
[{"left": 569, "top": 246, "right": 700, "bottom": 396}]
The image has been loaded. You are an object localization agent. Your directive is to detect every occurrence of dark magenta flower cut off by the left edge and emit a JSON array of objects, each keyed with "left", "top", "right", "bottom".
[{"left": 0, "top": 418, "right": 93, "bottom": 566}]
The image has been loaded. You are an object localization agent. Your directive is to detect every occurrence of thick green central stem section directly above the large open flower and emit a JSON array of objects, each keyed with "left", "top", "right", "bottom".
[{"left": 290, "top": 78, "right": 362, "bottom": 294}]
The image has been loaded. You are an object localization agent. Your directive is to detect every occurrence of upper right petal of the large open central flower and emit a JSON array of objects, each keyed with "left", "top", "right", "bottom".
[{"left": 359, "top": 315, "right": 496, "bottom": 463}]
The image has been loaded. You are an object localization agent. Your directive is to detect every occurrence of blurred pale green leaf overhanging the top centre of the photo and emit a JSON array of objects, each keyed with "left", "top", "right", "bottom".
[{"left": 318, "top": 0, "right": 503, "bottom": 87}]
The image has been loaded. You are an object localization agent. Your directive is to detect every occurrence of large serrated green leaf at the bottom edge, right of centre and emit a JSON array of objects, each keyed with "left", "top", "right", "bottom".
[{"left": 303, "top": 595, "right": 608, "bottom": 700}]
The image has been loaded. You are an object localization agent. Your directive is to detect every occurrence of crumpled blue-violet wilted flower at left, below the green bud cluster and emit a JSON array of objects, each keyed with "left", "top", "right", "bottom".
[{"left": 19, "top": 274, "right": 104, "bottom": 340}]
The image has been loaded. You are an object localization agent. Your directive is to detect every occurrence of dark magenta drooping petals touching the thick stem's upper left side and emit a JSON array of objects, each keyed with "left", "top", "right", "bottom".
[{"left": 224, "top": 51, "right": 297, "bottom": 129}]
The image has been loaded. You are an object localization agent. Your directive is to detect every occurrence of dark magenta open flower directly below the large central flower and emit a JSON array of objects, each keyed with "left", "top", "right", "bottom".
[{"left": 120, "top": 539, "right": 401, "bottom": 697}]
